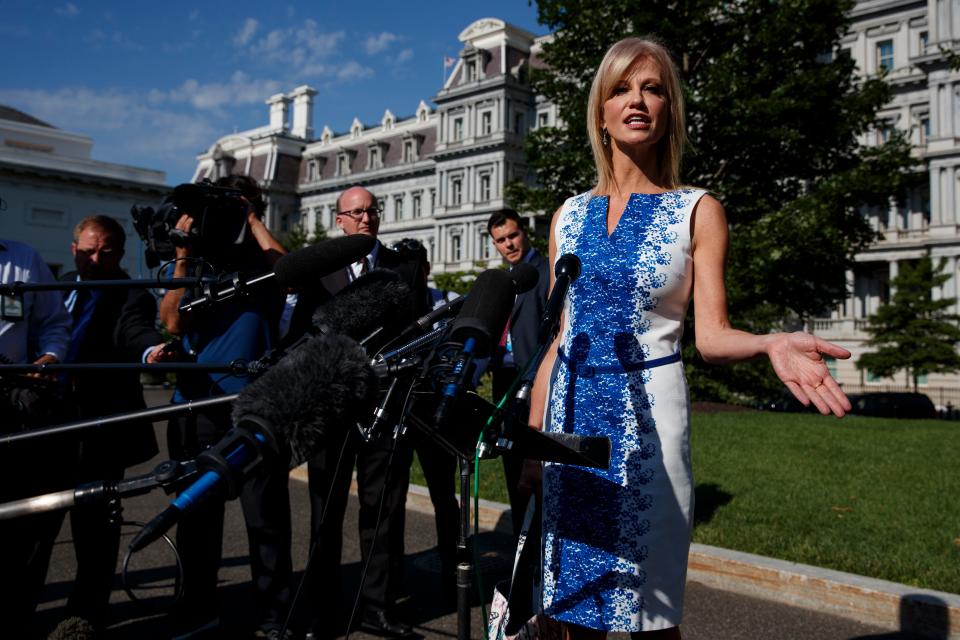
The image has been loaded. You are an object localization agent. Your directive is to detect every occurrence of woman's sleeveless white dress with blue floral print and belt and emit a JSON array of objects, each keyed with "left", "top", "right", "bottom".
[{"left": 542, "top": 189, "right": 704, "bottom": 631}]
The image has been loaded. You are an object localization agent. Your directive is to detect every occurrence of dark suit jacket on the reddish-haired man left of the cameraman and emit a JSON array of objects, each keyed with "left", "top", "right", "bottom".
[{"left": 61, "top": 272, "right": 163, "bottom": 467}]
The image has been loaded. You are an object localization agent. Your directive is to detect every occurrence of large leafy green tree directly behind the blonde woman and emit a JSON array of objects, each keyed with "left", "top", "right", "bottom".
[{"left": 508, "top": 0, "right": 915, "bottom": 400}]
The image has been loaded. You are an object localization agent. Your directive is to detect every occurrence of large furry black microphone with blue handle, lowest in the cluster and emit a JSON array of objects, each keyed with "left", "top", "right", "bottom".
[{"left": 130, "top": 334, "right": 377, "bottom": 551}]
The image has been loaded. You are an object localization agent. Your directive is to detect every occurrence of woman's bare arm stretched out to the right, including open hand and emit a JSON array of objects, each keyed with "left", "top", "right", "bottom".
[{"left": 693, "top": 196, "right": 850, "bottom": 416}]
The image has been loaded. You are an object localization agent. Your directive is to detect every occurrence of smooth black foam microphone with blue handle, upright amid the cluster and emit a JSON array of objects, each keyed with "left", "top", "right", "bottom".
[{"left": 434, "top": 269, "right": 515, "bottom": 426}]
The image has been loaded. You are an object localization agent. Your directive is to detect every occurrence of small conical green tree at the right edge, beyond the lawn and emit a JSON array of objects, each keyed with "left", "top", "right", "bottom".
[{"left": 857, "top": 256, "right": 960, "bottom": 391}]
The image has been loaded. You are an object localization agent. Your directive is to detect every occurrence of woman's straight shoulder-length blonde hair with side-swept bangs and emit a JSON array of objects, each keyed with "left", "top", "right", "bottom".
[{"left": 587, "top": 38, "right": 687, "bottom": 193}]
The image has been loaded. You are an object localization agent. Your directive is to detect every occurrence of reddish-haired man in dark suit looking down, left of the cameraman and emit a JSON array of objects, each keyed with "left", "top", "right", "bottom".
[{"left": 62, "top": 216, "right": 166, "bottom": 630}]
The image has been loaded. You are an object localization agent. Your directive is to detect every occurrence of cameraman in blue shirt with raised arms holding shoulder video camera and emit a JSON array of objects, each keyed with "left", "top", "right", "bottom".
[{"left": 160, "top": 176, "right": 292, "bottom": 638}]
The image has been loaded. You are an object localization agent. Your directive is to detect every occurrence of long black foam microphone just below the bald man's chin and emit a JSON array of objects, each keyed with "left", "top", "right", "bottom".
[{"left": 179, "top": 234, "right": 376, "bottom": 313}]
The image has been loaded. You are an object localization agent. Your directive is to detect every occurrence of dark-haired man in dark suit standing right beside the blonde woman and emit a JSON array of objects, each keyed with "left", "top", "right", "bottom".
[{"left": 487, "top": 209, "right": 550, "bottom": 534}]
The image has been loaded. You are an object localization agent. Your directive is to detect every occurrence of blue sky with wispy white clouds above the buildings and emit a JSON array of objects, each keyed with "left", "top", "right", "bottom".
[{"left": 0, "top": 0, "right": 545, "bottom": 184}]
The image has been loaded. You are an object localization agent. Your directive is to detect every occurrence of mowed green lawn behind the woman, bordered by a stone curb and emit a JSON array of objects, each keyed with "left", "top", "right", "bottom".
[{"left": 413, "top": 412, "right": 960, "bottom": 593}]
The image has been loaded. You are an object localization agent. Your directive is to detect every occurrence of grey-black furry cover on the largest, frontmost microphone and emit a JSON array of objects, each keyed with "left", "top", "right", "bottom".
[{"left": 233, "top": 334, "right": 377, "bottom": 469}]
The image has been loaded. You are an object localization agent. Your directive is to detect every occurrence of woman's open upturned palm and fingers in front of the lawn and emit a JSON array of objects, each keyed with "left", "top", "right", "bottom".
[{"left": 767, "top": 331, "right": 851, "bottom": 417}]
